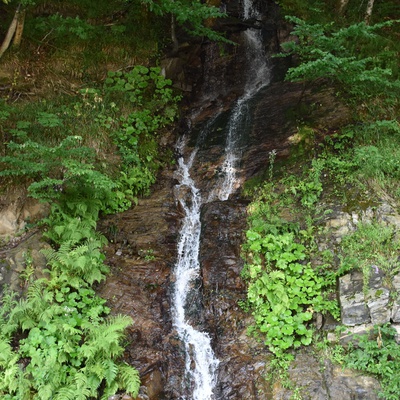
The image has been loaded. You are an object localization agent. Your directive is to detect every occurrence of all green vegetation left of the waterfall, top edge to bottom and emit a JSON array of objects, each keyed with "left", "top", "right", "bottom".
[{"left": 0, "top": 0, "right": 227, "bottom": 400}]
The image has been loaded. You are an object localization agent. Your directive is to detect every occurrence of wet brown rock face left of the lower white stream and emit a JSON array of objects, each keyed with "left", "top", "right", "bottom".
[{"left": 100, "top": 182, "right": 183, "bottom": 400}]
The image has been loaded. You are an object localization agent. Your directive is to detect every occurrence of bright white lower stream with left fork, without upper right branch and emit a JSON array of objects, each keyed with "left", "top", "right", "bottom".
[{"left": 174, "top": 138, "right": 219, "bottom": 400}]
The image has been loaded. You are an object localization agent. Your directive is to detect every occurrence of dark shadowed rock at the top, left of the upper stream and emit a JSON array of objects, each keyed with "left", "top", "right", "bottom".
[{"left": 161, "top": 0, "right": 291, "bottom": 120}]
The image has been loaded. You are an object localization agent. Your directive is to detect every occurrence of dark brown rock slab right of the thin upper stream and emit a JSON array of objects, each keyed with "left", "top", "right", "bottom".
[{"left": 242, "top": 82, "right": 351, "bottom": 178}]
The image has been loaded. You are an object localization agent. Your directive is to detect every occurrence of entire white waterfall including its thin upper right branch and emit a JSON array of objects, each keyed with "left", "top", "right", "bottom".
[{"left": 173, "top": 0, "right": 269, "bottom": 400}]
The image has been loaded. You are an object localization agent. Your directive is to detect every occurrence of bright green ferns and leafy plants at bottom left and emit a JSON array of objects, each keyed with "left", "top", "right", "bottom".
[{"left": 0, "top": 184, "right": 140, "bottom": 400}]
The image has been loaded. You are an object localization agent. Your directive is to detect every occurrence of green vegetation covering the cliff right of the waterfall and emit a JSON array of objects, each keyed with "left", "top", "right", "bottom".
[{"left": 242, "top": 0, "right": 400, "bottom": 399}]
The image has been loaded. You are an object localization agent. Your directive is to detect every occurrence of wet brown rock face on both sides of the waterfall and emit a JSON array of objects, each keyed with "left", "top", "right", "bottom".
[{"left": 94, "top": 36, "right": 368, "bottom": 400}]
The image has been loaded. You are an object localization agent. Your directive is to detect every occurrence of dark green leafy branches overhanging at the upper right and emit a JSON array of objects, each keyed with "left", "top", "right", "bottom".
[{"left": 283, "top": 17, "right": 400, "bottom": 115}]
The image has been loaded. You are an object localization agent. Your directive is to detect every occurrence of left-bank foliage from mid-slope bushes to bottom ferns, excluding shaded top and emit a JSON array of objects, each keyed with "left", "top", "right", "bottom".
[{"left": 0, "top": 67, "right": 179, "bottom": 400}]
